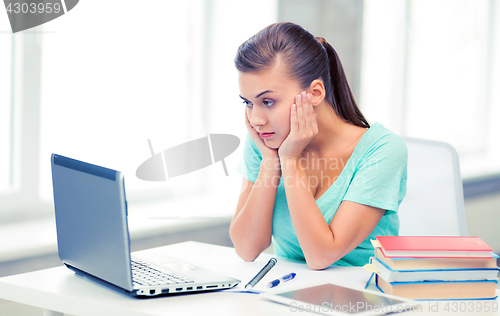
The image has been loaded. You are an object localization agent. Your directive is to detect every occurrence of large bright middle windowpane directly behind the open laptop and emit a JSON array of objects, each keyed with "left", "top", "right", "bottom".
[{"left": 39, "top": 1, "right": 195, "bottom": 199}]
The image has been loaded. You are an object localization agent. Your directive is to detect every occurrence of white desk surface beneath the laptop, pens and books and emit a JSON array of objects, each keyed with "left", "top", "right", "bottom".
[{"left": 0, "top": 242, "right": 500, "bottom": 316}]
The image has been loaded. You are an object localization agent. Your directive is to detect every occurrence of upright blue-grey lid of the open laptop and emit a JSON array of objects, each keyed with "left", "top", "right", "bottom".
[{"left": 51, "top": 154, "right": 133, "bottom": 291}]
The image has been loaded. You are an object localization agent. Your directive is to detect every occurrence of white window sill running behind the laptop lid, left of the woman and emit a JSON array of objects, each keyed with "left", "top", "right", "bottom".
[{"left": 0, "top": 195, "right": 236, "bottom": 262}]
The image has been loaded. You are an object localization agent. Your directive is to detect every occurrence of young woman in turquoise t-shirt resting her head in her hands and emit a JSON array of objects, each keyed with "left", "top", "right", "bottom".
[{"left": 230, "top": 23, "right": 407, "bottom": 269}]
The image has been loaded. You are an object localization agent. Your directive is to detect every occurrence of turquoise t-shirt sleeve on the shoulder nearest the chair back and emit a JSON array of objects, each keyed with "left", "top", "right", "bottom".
[{"left": 343, "top": 134, "right": 408, "bottom": 214}]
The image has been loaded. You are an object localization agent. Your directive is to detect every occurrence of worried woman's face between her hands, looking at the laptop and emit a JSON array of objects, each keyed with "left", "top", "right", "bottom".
[{"left": 239, "top": 64, "right": 304, "bottom": 149}]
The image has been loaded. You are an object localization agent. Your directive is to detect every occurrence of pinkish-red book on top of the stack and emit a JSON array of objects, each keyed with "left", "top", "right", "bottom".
[{"left": 377, "top": 236, "right": 492, "bottom": 258}]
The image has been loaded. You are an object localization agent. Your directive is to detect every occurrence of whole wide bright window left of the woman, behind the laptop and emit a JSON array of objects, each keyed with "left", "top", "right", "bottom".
[{"left": 0, "top": 0, "right": 276, "bottom": 215}]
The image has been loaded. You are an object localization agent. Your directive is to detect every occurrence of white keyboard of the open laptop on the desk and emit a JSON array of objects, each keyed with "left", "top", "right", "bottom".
[{"left": 132, "top": 259, "right": 193, "bottom": 285}]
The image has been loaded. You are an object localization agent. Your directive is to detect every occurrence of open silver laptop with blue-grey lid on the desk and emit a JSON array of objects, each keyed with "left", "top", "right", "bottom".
[{"left": 51, "top": 154, "right": 240, "bottom": 297}]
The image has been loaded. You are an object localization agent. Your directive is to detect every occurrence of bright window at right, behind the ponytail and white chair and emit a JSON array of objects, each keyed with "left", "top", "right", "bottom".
[{"left": 361, "top": 0, "right": 500, "bottom": 177}]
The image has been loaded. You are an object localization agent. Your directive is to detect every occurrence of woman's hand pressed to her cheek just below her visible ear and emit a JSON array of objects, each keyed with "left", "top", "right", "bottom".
[{"left": 278, "top": 91, "right": 318, "bottom": 159}]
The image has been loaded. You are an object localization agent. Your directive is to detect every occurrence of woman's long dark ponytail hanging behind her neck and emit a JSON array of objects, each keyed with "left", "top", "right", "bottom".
[{"left": 316, "top": 37, "right": 370, "bottom": 127}]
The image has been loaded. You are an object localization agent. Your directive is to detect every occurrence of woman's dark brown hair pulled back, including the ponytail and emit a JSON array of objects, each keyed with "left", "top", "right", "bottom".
[{"left": 234, "top": 22, "right": 370, "bottom": 127}]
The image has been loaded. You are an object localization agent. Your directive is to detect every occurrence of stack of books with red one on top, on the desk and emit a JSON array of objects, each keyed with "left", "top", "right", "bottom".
[{"left": 365, "top": 236, "right": 499, "bottom": 300}]
